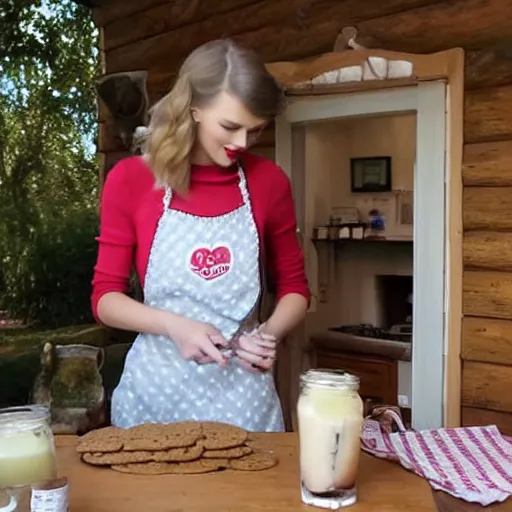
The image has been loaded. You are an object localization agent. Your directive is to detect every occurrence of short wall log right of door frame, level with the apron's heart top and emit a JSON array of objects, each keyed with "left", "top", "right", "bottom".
[{"left": 463, "top": 231, "right": 512, "bottom": 272}]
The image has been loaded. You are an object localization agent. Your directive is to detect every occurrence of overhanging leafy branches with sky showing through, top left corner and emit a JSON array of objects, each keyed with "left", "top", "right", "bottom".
[{"left": 0, "top": 0, "right": 99, "bottom": 138}]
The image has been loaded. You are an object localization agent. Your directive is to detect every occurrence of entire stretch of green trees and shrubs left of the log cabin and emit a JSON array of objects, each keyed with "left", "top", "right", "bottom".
[{"left": 0, "top": 0, "right": 99, "bottom": 328}]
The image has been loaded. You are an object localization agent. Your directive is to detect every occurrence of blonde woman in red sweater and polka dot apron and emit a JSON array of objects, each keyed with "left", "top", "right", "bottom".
[{"left": 92, "top": 40, "right": 310, "bottom": 431}]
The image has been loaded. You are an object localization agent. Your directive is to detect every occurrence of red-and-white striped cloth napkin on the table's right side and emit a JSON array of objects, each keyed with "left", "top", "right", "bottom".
[{"left": 361, "top": 407, "right": 512, "bottom": 506}]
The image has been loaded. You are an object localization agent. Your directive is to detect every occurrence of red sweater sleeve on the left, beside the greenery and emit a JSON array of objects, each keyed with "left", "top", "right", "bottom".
[{"left": 91, "top": 161, "right": 136, "bottom": 320}]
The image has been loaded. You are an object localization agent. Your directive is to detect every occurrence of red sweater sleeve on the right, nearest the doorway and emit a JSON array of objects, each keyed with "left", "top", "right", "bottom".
[{"left": 265, "top": 168, "right": 311, "bottom": 301}]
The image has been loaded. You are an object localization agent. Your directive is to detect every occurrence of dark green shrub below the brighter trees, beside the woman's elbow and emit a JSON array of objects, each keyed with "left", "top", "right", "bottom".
[{"left": 4, "top": 209, "right": 98, "bottom": 326}]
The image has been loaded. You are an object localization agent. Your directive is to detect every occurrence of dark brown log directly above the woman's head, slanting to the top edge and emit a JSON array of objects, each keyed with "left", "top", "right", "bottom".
[{"left": 104, "top": 0, "right": 440, "bottom": 72}]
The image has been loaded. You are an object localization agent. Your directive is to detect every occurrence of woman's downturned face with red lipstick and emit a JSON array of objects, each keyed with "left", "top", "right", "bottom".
[{"left": 192, "top": 92, "right": 268, "bottom": 167}]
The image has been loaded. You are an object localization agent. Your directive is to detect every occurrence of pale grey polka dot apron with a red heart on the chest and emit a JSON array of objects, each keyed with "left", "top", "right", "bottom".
[{"left": 112, "top": 165, "right": 284, "bottom": 432}]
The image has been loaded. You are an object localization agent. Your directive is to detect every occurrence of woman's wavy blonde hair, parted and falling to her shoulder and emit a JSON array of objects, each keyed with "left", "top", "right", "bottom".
[{"left": 144, "top": 39, "right": 284, "bottom": 193}]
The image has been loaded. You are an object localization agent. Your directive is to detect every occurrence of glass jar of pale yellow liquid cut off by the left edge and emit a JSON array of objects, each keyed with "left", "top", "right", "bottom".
[{"left": 0, "top": 405, "right": 57, "bottom": 489}]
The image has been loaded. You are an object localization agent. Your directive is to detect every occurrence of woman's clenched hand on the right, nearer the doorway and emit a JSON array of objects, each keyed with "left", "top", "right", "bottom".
[{"left": 235, "top": 326, "right": 277, "bottom": 372}]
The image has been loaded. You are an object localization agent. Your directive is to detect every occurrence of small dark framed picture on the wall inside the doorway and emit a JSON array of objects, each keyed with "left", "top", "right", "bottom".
[{"left": 350, "top": 156, "right": 391, "bottom": 192}]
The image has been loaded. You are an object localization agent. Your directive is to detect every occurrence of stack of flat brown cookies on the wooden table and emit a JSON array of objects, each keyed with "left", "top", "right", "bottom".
[{"left": 77, "top": 421, "right": 277, "bottom": 475}]
